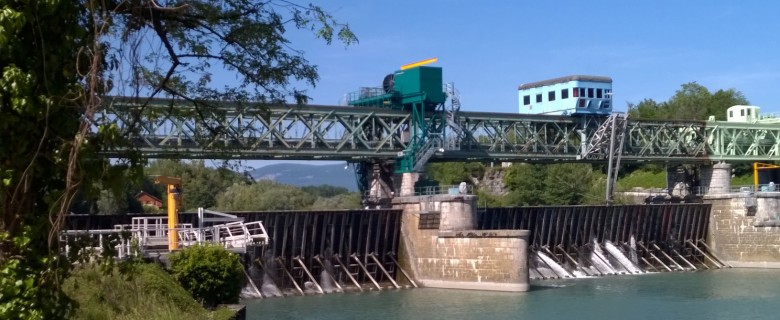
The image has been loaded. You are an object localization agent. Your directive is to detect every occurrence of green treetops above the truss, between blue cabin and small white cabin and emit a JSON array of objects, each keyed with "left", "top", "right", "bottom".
[{"left": 628, "top": 82, "right": 750, "bottom": 120}]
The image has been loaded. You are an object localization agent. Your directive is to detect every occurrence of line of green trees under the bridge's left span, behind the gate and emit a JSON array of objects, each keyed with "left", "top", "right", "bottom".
[{"left": 71, "top": 160, "right": 361, "bottom": 214}]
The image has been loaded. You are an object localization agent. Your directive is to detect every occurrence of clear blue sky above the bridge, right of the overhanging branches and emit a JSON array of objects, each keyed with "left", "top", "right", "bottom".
[{"left": 254, "top": 0, "right": 780, "bottom": 169}]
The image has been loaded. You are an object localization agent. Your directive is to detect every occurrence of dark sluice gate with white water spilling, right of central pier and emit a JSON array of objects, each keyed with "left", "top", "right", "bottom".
[{"left": 477, "top": 204, "right": 726, "bottom": 279}]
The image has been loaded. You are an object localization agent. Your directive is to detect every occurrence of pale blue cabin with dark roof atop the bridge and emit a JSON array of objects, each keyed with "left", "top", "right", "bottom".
[{"left": 518, "top": 75, "right": 612, "bottom": 115}]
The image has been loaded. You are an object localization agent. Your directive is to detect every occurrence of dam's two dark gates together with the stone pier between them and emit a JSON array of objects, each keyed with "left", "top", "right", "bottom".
[{"left": 68, "top": 195, "right": 728, "bottom": 297}]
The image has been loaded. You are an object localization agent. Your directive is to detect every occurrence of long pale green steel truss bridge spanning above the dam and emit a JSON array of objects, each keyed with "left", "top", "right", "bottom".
[{"left": 95, "top": 97, "right": 780, "bottom": 163}]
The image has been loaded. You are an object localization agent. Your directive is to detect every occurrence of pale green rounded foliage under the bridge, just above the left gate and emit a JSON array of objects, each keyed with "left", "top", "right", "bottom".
[{"left": 217, "top": 180, "right": 317, "bottom": 211}]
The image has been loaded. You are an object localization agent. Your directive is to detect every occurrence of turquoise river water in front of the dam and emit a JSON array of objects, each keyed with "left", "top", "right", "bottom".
[{"left": 244, "top": 269, "right": 780, "bottom": 320}]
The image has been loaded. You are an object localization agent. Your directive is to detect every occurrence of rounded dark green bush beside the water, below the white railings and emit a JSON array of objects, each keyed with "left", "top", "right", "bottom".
[{"left": 170, "top": 245, "right": 246, "bottom": 307}]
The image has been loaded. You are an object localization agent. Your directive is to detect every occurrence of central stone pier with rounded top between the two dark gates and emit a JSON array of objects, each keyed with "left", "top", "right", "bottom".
[{"left": 393, "top": 195, "right": 529, "bottom": 292}]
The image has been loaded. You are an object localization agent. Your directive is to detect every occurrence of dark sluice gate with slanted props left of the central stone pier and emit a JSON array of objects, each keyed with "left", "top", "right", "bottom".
[{"left": 67, "top": 209, "right": 408, "bottom": 297}]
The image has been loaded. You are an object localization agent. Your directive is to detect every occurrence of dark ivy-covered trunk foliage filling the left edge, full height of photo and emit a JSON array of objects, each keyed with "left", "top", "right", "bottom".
[{"left": 0, "top": 0, "right": 88, "bottom": 319}]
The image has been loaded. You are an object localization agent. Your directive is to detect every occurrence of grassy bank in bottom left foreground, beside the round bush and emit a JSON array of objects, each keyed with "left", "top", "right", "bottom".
[{"left": 64, "top": 264, "right": 232, "bottom": 320}]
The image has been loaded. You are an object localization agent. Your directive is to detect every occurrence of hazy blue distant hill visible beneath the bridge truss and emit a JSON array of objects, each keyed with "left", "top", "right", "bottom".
[{"left": 249, "top": 163, "right": 357, "bottom": 191}]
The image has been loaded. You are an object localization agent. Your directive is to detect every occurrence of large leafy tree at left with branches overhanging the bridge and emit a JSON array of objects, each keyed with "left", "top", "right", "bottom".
[{"left": 0, "top": 0, "right": 356, "bottom": 319}]
